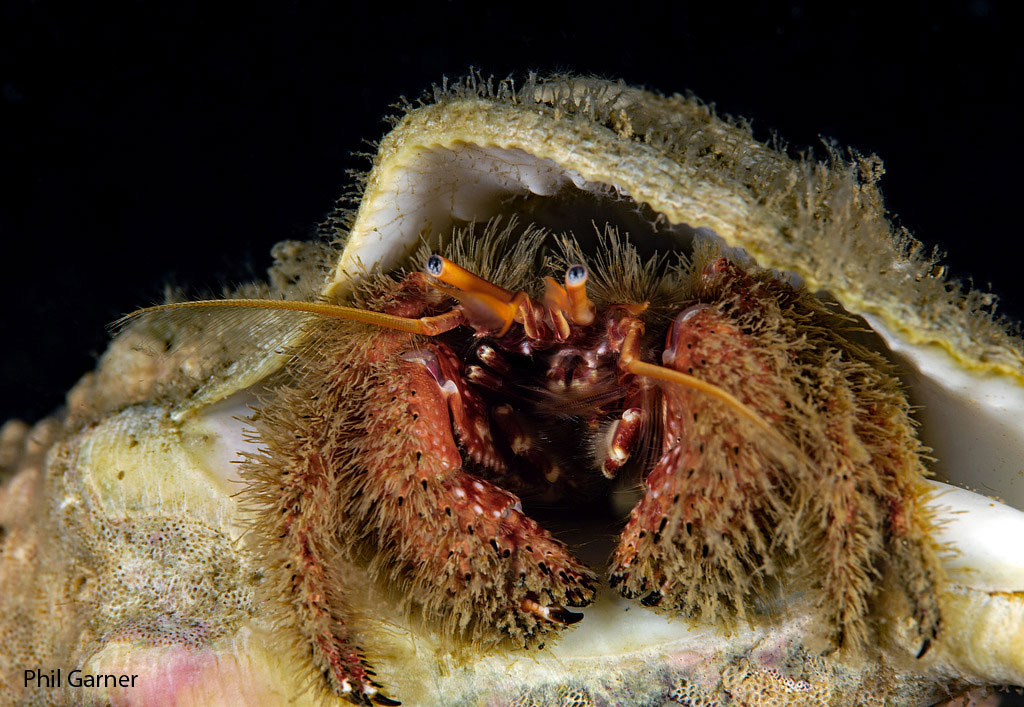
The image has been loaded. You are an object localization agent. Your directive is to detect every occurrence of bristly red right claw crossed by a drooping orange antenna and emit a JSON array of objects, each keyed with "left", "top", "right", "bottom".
[{"left": 610, "top": 299, "right": 792, "bottom": 619}]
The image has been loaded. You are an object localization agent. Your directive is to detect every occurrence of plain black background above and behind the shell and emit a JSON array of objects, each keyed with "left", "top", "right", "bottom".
[{"left": 0, "top": 1, "right": 1024, "bottom": 430}]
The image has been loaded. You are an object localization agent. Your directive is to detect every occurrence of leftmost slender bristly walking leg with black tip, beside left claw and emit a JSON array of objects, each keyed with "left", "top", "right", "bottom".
[{"left": 242, "top": 331, "right": 397, "bottom": 704}]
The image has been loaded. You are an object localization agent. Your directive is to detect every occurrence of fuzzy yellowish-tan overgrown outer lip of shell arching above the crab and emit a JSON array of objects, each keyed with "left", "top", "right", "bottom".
[{"left": 333, "top": 74, "right": 1024, "bottom": 377}]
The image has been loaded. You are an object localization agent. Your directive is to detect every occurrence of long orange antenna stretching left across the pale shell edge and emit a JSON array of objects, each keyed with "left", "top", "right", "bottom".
[{"left": 112, "top": 299, "right": 464, "bottom": 336}]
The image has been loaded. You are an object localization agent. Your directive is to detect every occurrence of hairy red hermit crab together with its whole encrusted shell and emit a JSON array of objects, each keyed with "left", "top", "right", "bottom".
[{"left": 0, "top": 77, "right": 1024, "bottom": 705}]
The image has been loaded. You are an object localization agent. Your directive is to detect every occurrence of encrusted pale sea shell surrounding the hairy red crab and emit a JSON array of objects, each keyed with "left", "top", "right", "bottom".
[{"left": 0, "top": 78, "right": 1024, "bottom": 705}]
